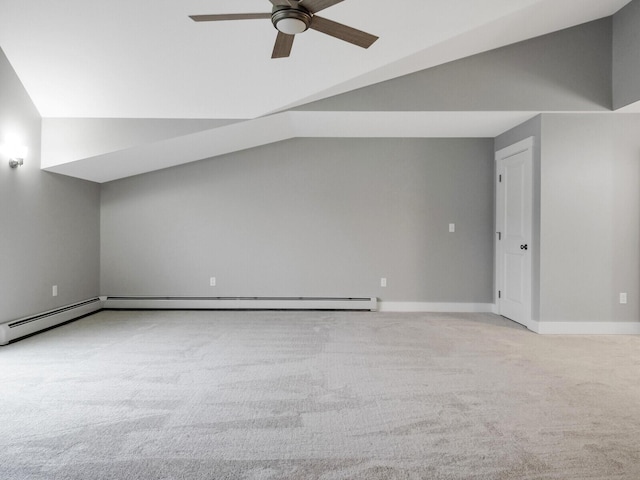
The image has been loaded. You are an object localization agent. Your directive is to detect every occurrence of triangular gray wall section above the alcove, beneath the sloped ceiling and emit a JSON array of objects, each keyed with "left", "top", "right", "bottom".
[{"left": 297, "top": 17, "right": 612, "bottom": 111}]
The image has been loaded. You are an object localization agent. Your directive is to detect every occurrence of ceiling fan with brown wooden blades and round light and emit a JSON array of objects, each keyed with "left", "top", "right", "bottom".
[{"left": 189, "top": 0, "right": 378, "bottom": 58}]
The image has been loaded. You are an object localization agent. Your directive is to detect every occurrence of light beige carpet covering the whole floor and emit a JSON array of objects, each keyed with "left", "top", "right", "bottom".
[{"left": 0, "top": 311, "right": 640, "bottom": 480}]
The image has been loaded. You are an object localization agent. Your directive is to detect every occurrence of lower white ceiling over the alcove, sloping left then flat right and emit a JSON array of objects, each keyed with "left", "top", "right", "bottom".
[{"left": 42, "top": 111, "right": 535, "bottom": 183}]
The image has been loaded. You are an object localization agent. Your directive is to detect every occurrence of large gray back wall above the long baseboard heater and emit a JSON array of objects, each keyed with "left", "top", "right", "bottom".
[{"left": 101, "top": 139, "right": 494, "bottom": 302}]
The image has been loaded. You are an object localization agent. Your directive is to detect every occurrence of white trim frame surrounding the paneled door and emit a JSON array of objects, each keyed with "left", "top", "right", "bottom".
[{"left": 495, "top": 137, "right": 534, "bottom": 329}]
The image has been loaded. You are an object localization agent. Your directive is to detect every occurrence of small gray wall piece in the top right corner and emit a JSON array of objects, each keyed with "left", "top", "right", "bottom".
[{"left": 613, "top": 0, "right": 640, "bottom": 109}]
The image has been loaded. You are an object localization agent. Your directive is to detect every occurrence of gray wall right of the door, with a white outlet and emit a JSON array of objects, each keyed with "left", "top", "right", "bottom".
[{"left": 540, "top": 114, "right": 640, "bottom": 322}]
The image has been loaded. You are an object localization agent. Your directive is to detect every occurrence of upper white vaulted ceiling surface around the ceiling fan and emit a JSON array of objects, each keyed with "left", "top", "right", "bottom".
[{"left": 0, "top": 0, "right": 629, "bottom": 119}]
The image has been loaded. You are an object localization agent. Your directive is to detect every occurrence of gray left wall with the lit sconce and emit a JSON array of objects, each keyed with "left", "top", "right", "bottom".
[{"left": 0, "top": 50, "right": 100, "bottom": 322}]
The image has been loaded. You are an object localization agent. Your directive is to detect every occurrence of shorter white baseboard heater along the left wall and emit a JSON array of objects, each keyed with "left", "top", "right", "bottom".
[{"left": 0, "top": 297, "right": 102, "bottom": 345}]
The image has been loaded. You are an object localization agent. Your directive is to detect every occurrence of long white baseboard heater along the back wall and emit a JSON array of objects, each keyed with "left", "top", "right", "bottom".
[{"left": 104, "top": 297, "right": 378, "bottom": 311}]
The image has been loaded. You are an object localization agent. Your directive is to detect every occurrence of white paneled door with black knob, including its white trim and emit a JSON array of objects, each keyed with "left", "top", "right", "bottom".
[{"left": 496, "top": 138, "right": 533, "bottom": 327}]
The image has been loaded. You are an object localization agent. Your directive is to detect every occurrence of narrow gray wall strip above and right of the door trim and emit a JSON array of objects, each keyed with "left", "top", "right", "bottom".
[{"left": 495, "top": 115, "right": 542, "bottom": 321}]
